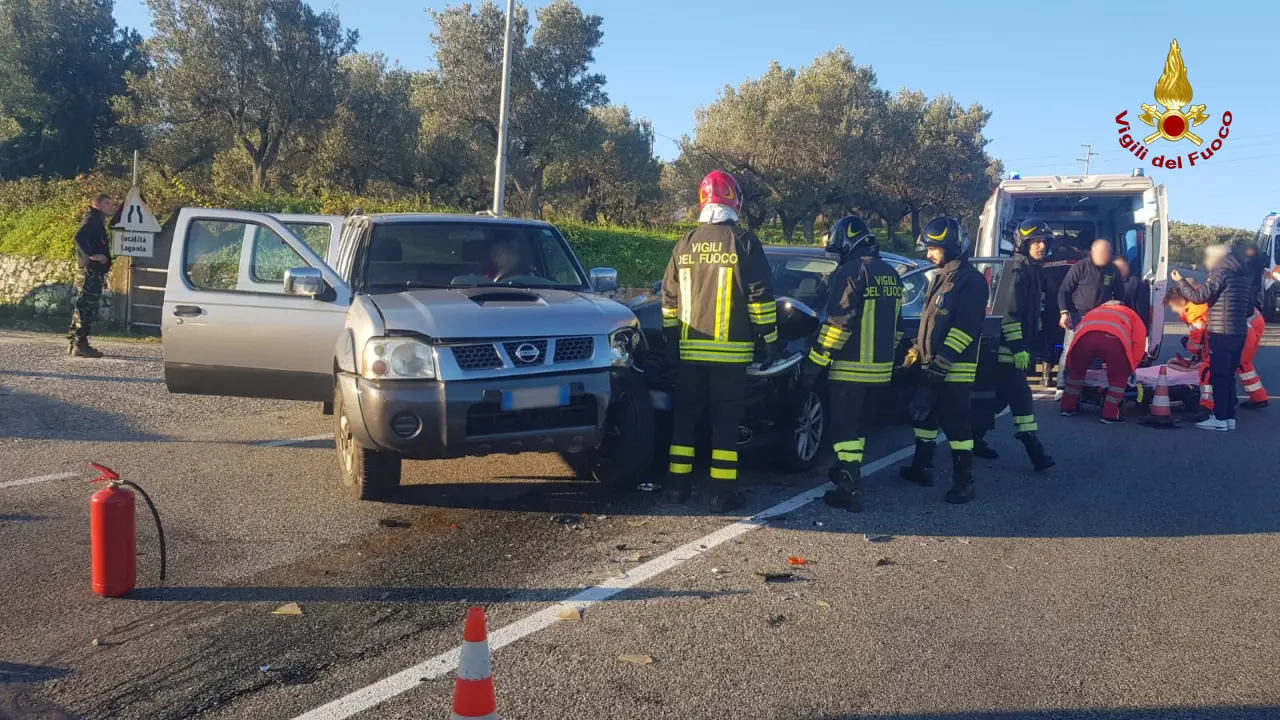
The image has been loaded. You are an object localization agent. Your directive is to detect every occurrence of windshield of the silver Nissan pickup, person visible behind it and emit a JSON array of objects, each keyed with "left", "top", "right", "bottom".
[{"left": 364, "top": 222, "right": 586, "bottom": 291}]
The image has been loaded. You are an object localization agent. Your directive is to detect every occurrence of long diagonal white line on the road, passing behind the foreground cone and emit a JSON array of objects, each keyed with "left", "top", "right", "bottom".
[{"left": 294, "top": 438, "right": 926, "bottom": 720}]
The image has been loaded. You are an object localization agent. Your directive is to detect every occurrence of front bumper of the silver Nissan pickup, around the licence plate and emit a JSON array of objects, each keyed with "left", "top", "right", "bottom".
[{"left": 338, "top": 370, "right": 612, "bottom": 460}]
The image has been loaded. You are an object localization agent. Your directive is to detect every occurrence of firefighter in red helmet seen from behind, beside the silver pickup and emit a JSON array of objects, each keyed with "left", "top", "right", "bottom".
[{"left": 662, "top": 170, "right": 780, "bottom": 512}]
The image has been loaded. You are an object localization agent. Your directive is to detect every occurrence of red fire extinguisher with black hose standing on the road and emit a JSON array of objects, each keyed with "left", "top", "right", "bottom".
[{"left": 88, "top": 462, "right": 166, "bottom": 597}]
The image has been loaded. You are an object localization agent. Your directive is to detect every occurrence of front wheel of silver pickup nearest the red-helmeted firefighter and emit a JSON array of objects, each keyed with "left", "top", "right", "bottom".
[{"left": 578, "top": 372, "right": 657, "bottom": 489}]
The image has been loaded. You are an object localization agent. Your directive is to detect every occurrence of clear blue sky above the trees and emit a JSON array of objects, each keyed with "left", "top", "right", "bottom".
[{"left": 116, "top": 0, "right": 1280, "bottom": 229}]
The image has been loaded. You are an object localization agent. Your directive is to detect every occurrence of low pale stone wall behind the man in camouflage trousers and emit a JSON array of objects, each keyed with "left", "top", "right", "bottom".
[{"left": 0, "top": 255, "right": 124, "bottom": 322}]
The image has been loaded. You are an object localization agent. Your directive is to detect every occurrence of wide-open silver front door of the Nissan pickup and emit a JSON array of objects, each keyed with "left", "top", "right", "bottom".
[{"left": 161, "top": 208, "right": 351, "bottom": 401}]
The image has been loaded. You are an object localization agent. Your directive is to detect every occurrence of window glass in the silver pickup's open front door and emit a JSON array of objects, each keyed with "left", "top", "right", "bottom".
[{"left": 183, "top": 219, "right": 307, "bottom": 295}]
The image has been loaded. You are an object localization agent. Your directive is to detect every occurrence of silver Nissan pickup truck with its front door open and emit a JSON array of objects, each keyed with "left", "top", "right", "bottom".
[{"left": 161, "top": 208, "right": 654, "bottom": 500}]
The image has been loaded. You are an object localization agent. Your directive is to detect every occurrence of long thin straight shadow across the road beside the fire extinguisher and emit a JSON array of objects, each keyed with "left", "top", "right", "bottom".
[{"left": 127, "top": 587, "right": 740, "bottom": 599}]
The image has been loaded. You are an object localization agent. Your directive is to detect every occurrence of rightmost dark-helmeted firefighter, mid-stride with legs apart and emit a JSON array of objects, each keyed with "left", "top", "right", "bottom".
[{"left": 973, "top": 220, "right": 1055, "bottom": 471}]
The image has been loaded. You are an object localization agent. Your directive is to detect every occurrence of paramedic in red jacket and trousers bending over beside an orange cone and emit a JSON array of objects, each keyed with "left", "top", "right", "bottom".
[{"left": 1062, "top": 300, "right": 1147, "bottom": 424}]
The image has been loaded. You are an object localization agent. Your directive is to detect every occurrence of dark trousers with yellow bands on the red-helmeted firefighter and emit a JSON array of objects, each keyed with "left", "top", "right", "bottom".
[{"left": 667, "top": 363, "right": 746, "bottom": 492}]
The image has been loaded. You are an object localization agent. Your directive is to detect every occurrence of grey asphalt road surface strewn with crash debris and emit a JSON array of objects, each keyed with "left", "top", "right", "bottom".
[{"left": 0, "top": 326, "right": 1280, "bottom": 720}]
